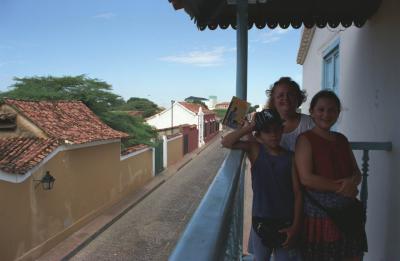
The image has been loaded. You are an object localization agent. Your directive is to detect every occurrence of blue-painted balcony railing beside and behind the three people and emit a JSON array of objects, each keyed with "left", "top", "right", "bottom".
[{"left": 169, "top": 142, "right": 392, "bottom": 261}]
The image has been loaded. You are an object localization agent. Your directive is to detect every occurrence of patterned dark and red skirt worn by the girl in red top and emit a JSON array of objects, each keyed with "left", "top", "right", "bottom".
[{"left": 302, "top": 190, "right": 368, "bottom": 261}]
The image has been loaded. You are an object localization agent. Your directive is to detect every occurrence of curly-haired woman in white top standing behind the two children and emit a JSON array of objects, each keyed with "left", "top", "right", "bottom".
[{"left": 266, "top": 77, "right": 314, "bottom": 151}]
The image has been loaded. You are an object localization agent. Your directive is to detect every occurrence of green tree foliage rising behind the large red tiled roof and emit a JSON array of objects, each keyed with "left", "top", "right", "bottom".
[{"left": 0, "top": 75, "right": 157, "bottom": 147}]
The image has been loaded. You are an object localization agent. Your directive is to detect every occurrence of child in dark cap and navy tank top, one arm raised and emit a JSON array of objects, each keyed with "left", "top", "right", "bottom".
[{"left": 222, "top": 110, "right": 302, "bottom": 261}]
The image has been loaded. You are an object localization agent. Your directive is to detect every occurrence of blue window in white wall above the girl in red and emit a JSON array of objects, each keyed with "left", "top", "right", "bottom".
[{"left": 322, "top": 41, "right": 339, "bottom": 94}]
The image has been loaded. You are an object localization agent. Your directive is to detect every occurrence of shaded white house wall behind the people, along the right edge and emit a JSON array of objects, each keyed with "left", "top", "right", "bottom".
[{"left": 303, "top": 0, "right": 400, "bottom": 261}]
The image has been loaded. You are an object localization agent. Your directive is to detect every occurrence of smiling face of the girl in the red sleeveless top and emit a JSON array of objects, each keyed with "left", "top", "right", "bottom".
[{"left": 310, "top": 98, "right": 340, "bottom": 130}]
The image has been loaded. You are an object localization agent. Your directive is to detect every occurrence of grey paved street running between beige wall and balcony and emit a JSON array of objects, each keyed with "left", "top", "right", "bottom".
[{"left": 71, "top": 139, "right": 228, "bottom": 261}]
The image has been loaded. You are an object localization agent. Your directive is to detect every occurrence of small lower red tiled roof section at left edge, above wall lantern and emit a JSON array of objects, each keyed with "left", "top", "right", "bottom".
[{"left": 0, "top": 137, "right": 59, "bottom": 174}]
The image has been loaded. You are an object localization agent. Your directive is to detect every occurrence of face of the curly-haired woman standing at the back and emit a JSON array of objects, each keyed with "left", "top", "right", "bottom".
[{"left": 272, "top": 84, "right": 298, "bottom": 115}]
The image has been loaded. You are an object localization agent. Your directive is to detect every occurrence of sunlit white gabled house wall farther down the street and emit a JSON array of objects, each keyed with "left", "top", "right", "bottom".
[{"left": 146, "top": 103, "right": 198, "bottom": 129}]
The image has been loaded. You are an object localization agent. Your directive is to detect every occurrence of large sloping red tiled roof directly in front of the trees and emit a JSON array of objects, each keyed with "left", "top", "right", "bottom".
[{"left": 5, "top": 99, "right": 128, "bottom": 144}]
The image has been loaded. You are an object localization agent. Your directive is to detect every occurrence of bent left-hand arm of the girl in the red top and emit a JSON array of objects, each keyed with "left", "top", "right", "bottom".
[{"left": 295, "top": 135, "right": 341, "bottom": 192}]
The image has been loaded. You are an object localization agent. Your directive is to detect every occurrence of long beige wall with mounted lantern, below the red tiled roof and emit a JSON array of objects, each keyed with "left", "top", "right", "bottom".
[{"left": 0, "top": 142, "right": 153, "bottom": 261}]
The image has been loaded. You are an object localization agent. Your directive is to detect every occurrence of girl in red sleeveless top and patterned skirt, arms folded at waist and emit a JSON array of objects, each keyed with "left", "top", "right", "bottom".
[{"left": 295, "top": 90, "right": 367, "bottom": 261}]
